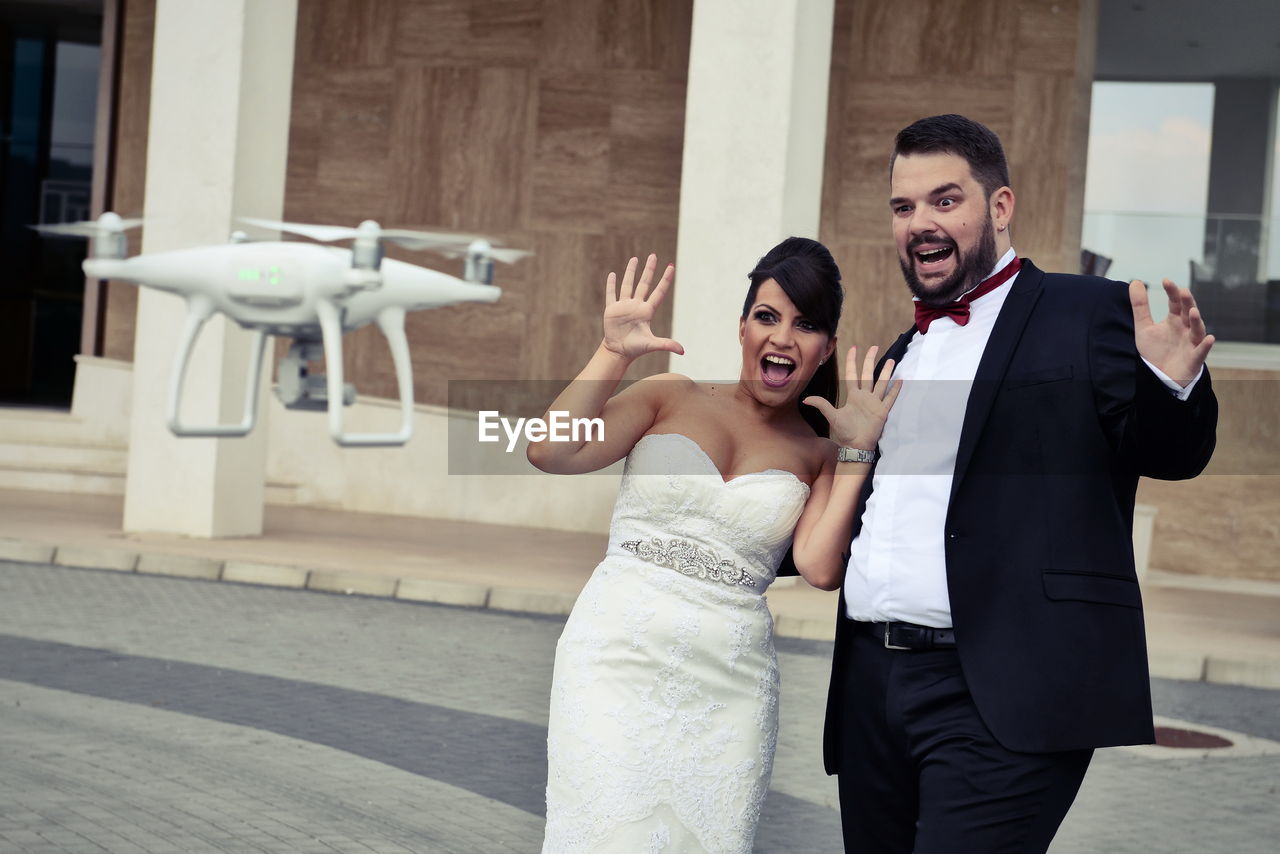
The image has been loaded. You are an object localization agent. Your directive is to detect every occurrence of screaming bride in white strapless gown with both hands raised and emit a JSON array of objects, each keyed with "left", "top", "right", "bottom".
[{"left": 529, "top": 237, "right": 897, "bottom": 854}]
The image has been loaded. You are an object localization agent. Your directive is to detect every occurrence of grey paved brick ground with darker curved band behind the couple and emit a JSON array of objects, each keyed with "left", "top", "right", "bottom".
[{"left": 0, "top": 563, "right": 1280, "bottom": 854}]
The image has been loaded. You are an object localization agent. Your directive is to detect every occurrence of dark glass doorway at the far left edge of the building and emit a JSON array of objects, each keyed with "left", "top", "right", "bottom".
[{"left": 0, "top": 1, "right": 102, "bottom": 407}]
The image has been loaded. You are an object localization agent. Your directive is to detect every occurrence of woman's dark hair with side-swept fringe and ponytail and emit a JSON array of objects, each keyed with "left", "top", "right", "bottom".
[{"left": 742, "top": 237, "right": 845, "bottom": 437}]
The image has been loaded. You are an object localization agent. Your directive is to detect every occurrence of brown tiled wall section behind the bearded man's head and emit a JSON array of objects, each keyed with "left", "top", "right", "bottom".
[{"left": 822, "top": 0, "right": 1097, "bottom": 346}]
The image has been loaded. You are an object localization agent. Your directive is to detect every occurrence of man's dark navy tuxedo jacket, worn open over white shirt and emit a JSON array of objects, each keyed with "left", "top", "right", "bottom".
[{"left": 823, "top": 260, "right": 1217, "bottom": 773}]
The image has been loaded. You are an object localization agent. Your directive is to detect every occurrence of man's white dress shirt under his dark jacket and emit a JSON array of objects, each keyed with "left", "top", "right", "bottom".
[{"left": 844, "top": 248, "right": 1203, "bottom": 629}]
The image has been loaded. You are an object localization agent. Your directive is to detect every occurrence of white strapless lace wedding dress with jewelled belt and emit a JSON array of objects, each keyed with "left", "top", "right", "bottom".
[{"left": 543, "top": 433, "right": 809, "bottom": 854}]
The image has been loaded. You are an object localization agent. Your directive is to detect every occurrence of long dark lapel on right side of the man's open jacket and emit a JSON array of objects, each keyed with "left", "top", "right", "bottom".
[{"left": 951, "top": 259, "right": 1044, "bottom": 501}]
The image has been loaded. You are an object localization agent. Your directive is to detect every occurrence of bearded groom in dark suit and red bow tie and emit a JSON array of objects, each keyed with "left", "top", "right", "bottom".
[{"left": 824, "top": 115, "right": 1217, "bottom": 854}]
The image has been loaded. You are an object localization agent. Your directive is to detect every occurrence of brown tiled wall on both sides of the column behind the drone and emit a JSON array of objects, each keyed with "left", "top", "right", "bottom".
[{"left": 106, "top": 0, "right": 692, "bottom": 414}]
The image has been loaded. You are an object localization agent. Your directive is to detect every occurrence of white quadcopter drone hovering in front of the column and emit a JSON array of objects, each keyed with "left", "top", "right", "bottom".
[{"left": 35, "top": 213, "right": 530, "bottom": 447}]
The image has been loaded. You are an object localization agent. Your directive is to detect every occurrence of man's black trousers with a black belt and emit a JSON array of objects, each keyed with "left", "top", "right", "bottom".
[{"left": 840, "top": 624, "right": 1093, "bottom": 854}]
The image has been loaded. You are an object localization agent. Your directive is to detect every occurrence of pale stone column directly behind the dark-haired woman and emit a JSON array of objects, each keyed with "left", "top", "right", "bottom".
[{"left": 671, "top": 0, "right": 835, "bottom": 380}]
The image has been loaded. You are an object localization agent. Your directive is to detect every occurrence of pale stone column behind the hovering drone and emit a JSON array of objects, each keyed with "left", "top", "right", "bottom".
[{"left": 124, "top": 0, "right": 297, "bottom": 536}]
